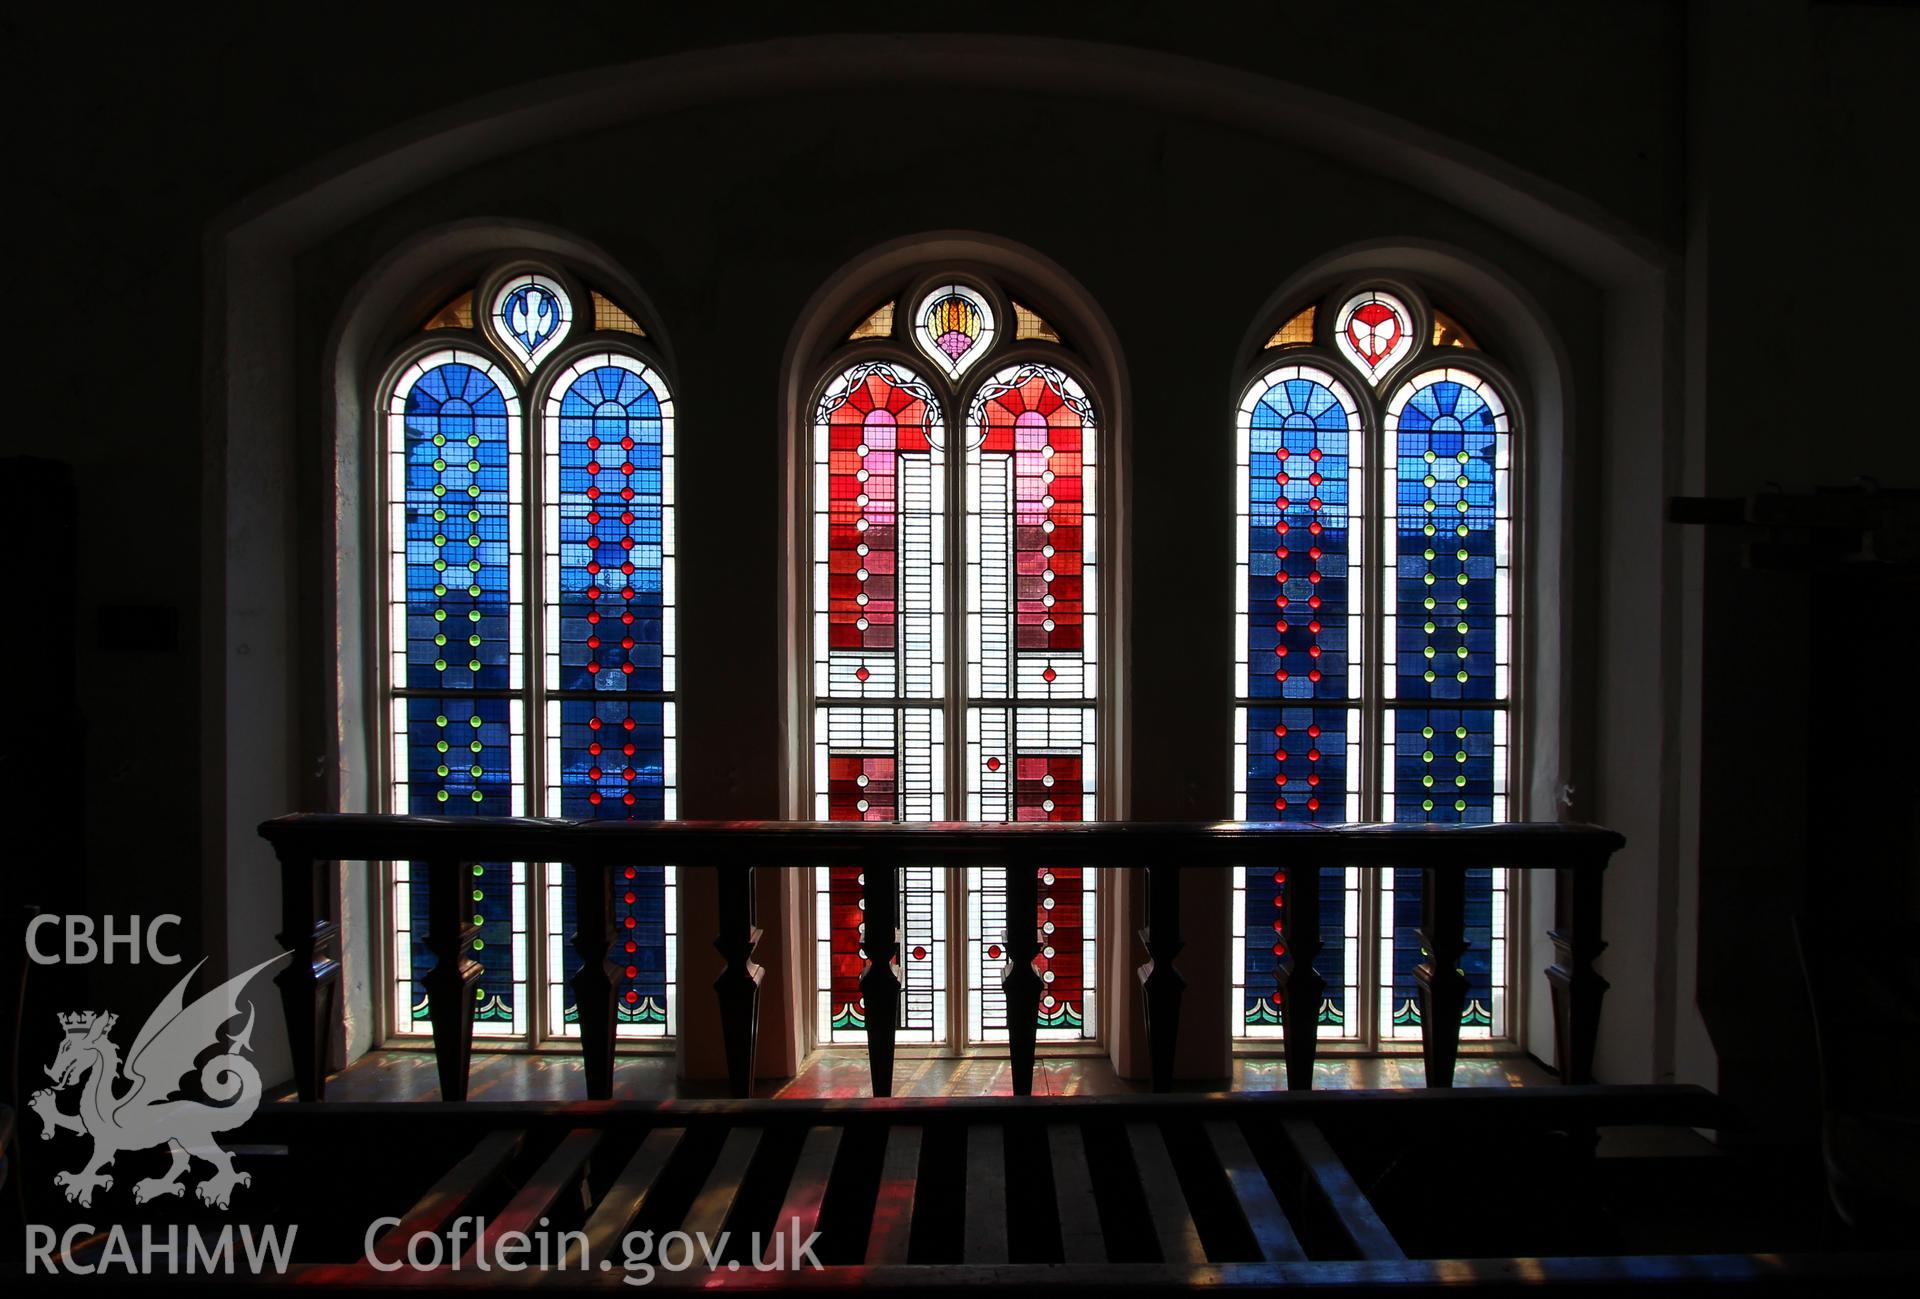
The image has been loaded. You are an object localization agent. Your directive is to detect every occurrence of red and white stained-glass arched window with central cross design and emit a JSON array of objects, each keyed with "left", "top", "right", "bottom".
[{"left": 806, "top": 276, "right": 1100, "bottom": 1046}]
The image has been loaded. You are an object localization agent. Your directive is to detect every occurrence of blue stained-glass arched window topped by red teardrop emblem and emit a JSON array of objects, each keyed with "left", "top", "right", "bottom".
[{"left": 1233, "top": 284, "right": 1515, "bottom": 1048}]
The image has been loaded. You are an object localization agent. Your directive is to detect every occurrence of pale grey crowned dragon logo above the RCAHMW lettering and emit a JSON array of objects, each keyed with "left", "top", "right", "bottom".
[{"left": 27, "top": 952, "right": 286, "bottom": 1209}]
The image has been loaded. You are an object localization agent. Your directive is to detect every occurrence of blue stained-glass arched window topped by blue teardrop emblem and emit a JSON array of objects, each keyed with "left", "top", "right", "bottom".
[{"left": 378, "top": 267, "right": 678, "bottom": 1042}]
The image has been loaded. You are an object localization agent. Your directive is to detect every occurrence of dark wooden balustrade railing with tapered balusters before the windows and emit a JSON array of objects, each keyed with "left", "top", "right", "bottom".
[{"left": 259, "top": 814, "right": 1624, "bottom": 1099}]
